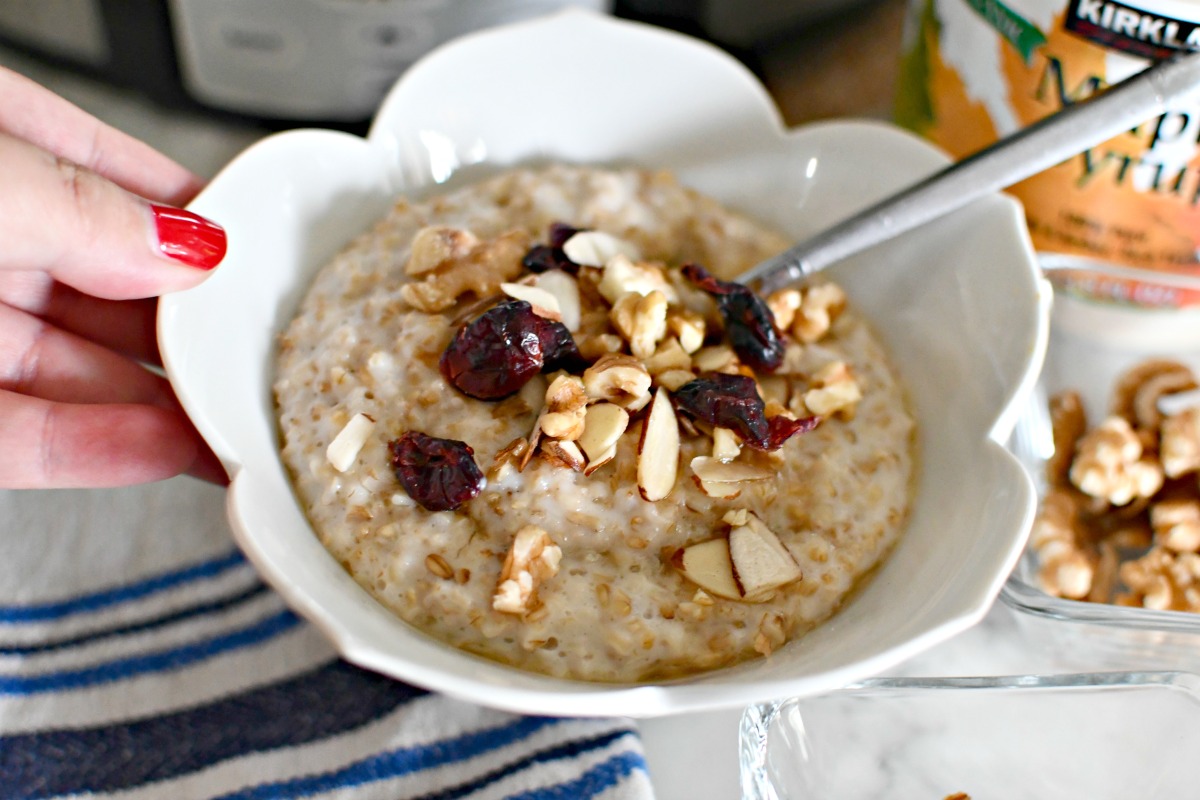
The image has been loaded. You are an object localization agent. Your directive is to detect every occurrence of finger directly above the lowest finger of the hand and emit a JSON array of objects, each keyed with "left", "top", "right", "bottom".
[{"left": 0, "top": 306, "right": 178, "bottom": 410}]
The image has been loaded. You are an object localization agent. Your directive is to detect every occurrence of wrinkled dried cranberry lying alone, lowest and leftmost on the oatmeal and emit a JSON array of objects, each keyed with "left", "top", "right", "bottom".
[{"left": 388, "top": 431, "right": 487, "bottom": 511}]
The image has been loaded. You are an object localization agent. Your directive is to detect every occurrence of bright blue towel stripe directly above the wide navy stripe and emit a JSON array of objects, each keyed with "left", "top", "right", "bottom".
[{"left": 0, "top": 610, "right": 300, "bottom": 694}]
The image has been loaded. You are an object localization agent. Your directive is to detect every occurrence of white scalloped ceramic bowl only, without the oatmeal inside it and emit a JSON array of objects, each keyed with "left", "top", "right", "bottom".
[{"left": 160, "top": 11, "right": 1049, "bottom": 716}]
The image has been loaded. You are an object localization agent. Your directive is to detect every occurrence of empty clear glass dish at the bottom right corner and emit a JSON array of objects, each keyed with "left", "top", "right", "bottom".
[{"left": 739, "top": 672, "right": 1200, "bottom": 800}]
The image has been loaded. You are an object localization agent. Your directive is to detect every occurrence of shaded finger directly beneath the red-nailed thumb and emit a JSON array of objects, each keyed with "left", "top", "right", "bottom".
[{"left": 0, "top": 271, "right": 162, "bottom": 365}]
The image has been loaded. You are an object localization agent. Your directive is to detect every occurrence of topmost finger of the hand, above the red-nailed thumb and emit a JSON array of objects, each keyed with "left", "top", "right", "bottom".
[{"left": 0, "top": 67, "right": 203, "bottom": 205}]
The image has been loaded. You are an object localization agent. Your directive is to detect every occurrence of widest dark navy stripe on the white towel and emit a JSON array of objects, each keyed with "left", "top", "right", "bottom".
[{"left": 0, "top": 661, "right": 426, "bottom": 800}]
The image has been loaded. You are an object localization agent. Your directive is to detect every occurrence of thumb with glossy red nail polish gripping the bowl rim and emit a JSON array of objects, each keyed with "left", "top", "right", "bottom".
[{"left": 0, "top": 134, "right": 226, "bottom": 300}]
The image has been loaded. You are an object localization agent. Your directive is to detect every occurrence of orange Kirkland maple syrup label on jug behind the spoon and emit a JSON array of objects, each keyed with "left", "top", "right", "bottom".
[{"left": 896, "top": 0, "right": 1200, "bottom": 307}]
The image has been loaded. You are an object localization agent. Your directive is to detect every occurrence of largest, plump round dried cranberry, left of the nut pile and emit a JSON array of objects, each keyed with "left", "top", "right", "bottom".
[{"left": 438, "top": 300, "right": 546, "bottom": 399}]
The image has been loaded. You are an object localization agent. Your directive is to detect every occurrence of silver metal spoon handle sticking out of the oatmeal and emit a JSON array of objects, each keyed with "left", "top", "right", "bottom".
[{"left": 738, "top": 53, "right": 1200, "bottom": 294}]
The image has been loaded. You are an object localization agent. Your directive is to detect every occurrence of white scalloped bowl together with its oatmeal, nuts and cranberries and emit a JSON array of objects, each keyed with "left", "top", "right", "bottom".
[{"left": 160, "top": 12, "right": 1048, "bottom": 716}]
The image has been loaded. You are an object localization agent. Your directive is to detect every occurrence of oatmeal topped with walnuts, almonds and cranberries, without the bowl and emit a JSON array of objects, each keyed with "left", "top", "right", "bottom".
[{"left": 275, "top": 167, "right": 914, "bottom": 681}]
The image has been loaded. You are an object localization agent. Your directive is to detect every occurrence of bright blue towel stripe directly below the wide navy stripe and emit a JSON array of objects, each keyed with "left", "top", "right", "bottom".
[{"left": 212, "top": 717, "right": 560, "bottom": 800}]
